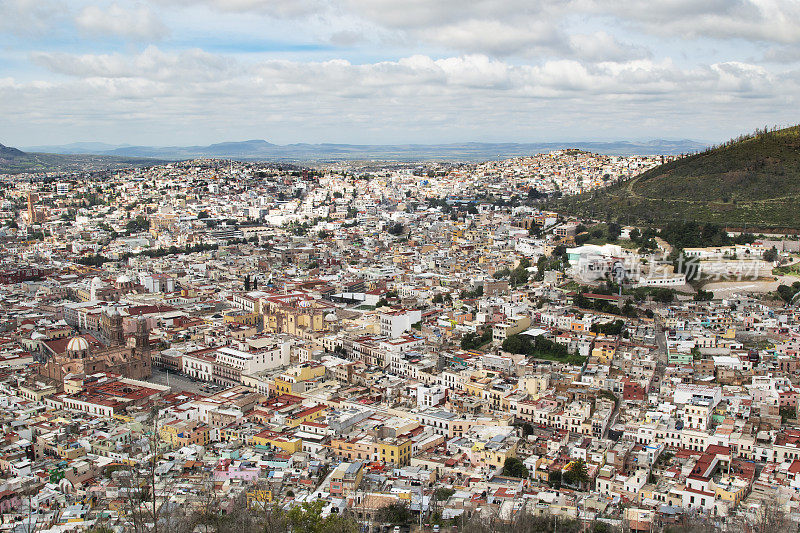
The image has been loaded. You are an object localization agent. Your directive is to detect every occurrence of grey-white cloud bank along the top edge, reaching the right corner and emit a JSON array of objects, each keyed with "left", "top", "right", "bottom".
[{"left": 154, "top": 0, "right": 800, "bottom": 46}]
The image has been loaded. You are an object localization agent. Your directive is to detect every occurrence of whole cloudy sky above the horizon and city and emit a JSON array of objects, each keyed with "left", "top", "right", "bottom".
[{"left": 0, "top": 0, "right": 800, "bottom": 146}]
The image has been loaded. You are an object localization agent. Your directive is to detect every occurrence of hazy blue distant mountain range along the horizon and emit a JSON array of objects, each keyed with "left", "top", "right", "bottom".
[{"left": 25, "top": 139, "right": 706, "bottom": 162}]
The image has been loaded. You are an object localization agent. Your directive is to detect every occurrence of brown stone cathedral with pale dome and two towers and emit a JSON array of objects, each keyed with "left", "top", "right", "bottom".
[{"left": 39, "top": 307, "right": 151, "bottom": 383}]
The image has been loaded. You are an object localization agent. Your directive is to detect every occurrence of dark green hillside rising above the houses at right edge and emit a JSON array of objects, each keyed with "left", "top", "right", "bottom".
[{"left": 551, "top": 126, "right": 800, "bottom": 229}]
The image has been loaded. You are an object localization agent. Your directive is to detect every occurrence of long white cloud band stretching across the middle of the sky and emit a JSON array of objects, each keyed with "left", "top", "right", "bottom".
[{"left": 18, "top": 46, "right": 800, "bottom": 127}]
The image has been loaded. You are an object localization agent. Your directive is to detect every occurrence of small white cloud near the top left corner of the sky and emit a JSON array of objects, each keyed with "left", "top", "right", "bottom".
[{"left": 75, "top": 4, "right": 168, "bottom": 40}]
